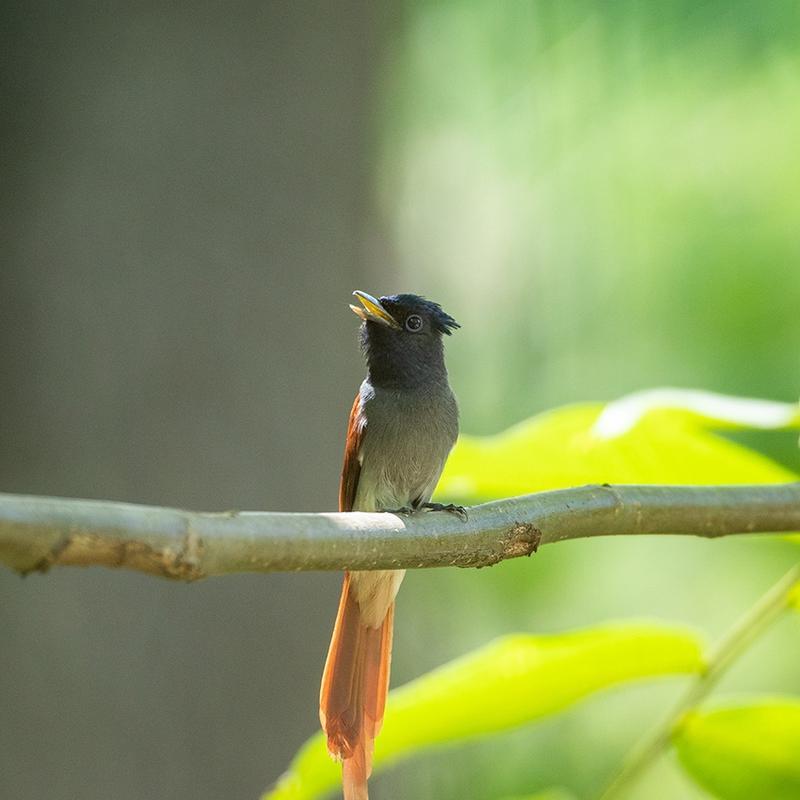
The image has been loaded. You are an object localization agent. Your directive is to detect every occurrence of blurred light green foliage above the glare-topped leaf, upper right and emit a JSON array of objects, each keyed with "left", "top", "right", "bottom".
[{"left": 380, "top": 0, "right": 800, "bottom": 433}]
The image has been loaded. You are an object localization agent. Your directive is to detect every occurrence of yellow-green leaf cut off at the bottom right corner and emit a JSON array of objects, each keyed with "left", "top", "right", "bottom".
[{"left": 675, "top": 697, "right": 800, "bottom": 800}]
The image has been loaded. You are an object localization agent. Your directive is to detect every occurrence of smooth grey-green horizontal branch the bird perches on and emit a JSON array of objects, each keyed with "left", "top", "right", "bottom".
[{"left": 0, "top": 483, "right": 800, "bottom": 580}]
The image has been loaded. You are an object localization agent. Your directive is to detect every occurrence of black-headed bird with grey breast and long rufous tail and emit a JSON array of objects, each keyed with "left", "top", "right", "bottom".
[{"left": 320, "top": 291, "right": 466, "bottom": 800}]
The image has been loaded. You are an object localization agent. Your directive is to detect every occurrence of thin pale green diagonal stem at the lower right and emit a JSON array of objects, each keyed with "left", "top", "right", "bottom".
[{"left": 600, "top": 564, "right": 800, "bottom": 800}]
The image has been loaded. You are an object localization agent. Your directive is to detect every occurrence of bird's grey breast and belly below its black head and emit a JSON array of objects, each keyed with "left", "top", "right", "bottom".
[{"left": 355, "top": 381, "right": 458, "bottom": 511}]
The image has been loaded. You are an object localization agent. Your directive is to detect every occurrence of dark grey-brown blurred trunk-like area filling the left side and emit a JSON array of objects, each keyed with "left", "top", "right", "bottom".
[{"left": 0, "top": 2, "right": 390, "bottom": 800}]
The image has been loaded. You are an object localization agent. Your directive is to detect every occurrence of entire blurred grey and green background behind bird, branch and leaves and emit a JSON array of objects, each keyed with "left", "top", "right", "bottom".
[{"left": 0, "top": 0, "right": 800, "bottom": 800}]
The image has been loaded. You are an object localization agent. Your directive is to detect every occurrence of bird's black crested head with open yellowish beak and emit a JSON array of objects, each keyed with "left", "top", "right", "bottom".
[{"left": 350, "top": 292, "right": 460, "bottom": 388}]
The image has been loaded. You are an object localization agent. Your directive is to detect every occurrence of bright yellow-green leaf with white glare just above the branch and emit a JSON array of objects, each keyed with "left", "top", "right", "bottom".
[{"left": 437, "top": 389, "right": 800, "bottom": 505}]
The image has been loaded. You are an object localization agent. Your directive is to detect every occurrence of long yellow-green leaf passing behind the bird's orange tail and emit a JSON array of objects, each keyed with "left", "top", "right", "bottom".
[{"left": 264, "top": 622, "right": 703, "bottom": 800}]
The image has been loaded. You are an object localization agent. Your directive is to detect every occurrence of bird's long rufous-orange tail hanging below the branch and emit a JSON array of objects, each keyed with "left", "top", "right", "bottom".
[{"left": 319, "top": 572, "right": 394, "bottom": 800}]
